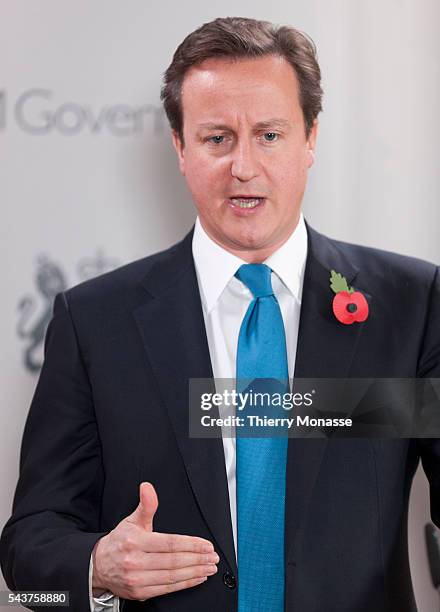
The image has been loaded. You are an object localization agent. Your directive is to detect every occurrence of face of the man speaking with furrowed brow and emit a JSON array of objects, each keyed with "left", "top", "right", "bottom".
[{"left": 173, "top": 56, "right": 317, "bottom": 262}]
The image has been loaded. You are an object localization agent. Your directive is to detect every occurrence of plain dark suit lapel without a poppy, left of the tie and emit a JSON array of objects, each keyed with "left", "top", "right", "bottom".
[{"left": 134, "top": 232, "right": 236, "bottom": 570}]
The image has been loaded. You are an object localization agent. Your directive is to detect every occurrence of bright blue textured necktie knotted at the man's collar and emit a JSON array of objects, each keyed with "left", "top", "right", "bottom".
[{"left": 236, "top": 264, "right": 288, "bottom": 612}]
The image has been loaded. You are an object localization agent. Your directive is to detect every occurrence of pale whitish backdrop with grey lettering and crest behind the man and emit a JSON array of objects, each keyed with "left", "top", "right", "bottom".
[{"left": 0, "top": 0, "right": 440, "bottom": 612}]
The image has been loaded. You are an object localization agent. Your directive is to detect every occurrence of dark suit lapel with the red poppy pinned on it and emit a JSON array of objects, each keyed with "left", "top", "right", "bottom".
[{"left": 286, "top": 225, "right": 371, "bottom": 562}]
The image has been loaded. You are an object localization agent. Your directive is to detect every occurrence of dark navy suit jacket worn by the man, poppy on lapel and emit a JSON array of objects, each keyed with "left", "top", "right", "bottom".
[{"left": 0, "top": 226, "right": 440, "bottom": 612}]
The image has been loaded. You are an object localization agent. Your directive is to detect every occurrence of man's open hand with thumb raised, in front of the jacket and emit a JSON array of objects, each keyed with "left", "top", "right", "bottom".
[{"left": 92, "top": 482, "right": 219, "bottom": 601}]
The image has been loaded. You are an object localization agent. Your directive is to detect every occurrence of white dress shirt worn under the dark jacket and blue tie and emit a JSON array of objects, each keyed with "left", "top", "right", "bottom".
[{"left": 89, "top": 213, "right": 307, "bottom": 612}]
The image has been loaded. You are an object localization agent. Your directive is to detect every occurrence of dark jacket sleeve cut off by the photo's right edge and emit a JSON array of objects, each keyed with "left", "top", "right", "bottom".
[{"left": 417, "top": 268, "right": 440, "bottom": 528}]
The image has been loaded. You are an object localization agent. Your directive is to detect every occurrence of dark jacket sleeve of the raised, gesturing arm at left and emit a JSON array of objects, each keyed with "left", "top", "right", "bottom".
[{"left": 0, "top": 293, "right": 105, "bottom": 612}]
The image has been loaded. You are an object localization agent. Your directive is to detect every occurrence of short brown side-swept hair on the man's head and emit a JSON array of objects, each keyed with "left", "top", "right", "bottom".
[{"left": 160, "top": 17, "right": 323, "bottom": 143}]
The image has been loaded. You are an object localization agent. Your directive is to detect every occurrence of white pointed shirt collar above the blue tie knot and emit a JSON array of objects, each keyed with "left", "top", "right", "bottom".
[{"left": 192, "top": 213, "right": 307, "bottom": 312}]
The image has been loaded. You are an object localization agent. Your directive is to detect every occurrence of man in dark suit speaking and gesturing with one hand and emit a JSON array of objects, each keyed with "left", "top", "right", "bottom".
[{"left": 0, "top": 18, "right": 440, "bottom": 612}]
